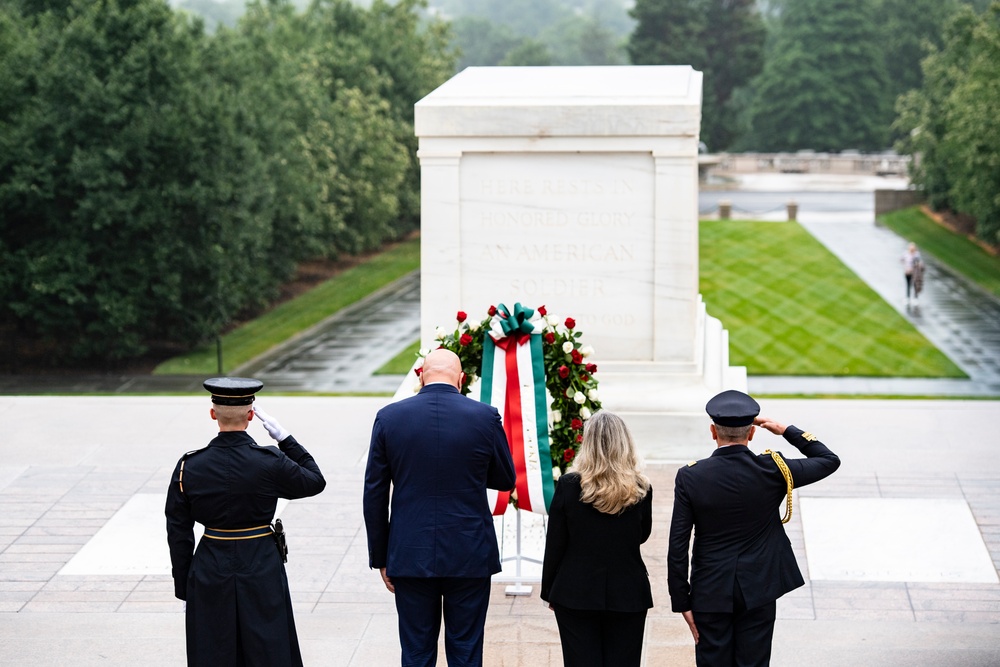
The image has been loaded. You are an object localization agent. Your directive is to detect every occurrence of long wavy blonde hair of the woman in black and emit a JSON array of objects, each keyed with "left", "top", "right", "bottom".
[{"left": 572, "top": 410, "right": 649, "bottom": 514}]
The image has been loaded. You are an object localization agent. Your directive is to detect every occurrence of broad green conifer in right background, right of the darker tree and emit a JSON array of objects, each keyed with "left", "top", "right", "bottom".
[{"left": 745, "top": 0, "right": 890, "bottom": 151}]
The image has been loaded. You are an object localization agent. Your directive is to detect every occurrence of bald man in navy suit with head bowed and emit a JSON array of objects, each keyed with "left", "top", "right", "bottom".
[{"left": 364, "top": 349, "right": 516, "bottom": 667}]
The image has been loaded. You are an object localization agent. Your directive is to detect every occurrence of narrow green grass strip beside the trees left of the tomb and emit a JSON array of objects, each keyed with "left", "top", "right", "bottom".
[{"left": 153, "top": 239, "right": 420, "bottom": 375}]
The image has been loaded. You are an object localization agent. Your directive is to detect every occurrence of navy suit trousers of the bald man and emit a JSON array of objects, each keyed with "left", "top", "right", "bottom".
[{"left": 392, "top": 577, "right": 490, "bottom": 667}]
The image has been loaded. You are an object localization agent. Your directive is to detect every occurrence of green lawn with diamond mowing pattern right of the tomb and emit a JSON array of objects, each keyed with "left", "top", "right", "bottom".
[{"left": 700, "top": 220, "right": 965, "bottom": 377}]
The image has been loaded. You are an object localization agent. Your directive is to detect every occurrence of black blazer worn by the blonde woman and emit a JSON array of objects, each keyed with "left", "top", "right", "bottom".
[{"left": 541, "top": 473, "right": 653, "bottom": 612}]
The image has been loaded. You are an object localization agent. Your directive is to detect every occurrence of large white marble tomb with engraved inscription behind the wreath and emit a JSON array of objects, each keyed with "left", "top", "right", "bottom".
[{"left": 404, "top": 66, "right": 746, "bottom": 459}]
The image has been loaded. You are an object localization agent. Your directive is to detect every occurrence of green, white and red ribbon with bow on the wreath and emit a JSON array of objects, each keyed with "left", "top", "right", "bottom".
[{"left": 479, "top": 303, "right": 555, "bottom": 516}]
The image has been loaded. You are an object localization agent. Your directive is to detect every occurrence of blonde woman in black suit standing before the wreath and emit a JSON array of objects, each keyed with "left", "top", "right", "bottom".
[{"left": 541, "top": 411, "right": 653, "bottom": 667}]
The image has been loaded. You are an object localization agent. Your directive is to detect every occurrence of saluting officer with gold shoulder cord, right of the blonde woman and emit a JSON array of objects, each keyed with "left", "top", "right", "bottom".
[{"left": 667, "top": 390, "right": 840, "bottom": 667}]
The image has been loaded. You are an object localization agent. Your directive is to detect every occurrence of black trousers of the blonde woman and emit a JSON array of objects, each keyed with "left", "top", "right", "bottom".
[{"left": 552, "top": 604, "right": 646, "bottom": 667}]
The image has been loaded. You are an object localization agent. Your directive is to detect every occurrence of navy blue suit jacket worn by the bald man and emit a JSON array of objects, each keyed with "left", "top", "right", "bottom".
[{"left": 364, "top": 384, "right": 516, "bottom": 577}]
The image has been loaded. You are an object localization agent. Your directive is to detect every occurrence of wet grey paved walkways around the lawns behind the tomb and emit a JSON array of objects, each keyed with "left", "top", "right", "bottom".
[{"left": 0, "top": 174, "right": 1000, "bottom": 397}]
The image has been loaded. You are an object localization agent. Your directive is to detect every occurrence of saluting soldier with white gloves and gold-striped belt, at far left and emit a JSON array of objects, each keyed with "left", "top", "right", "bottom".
[{"left": 166, "top": 378, "right": 326, "bottom": 667}]
